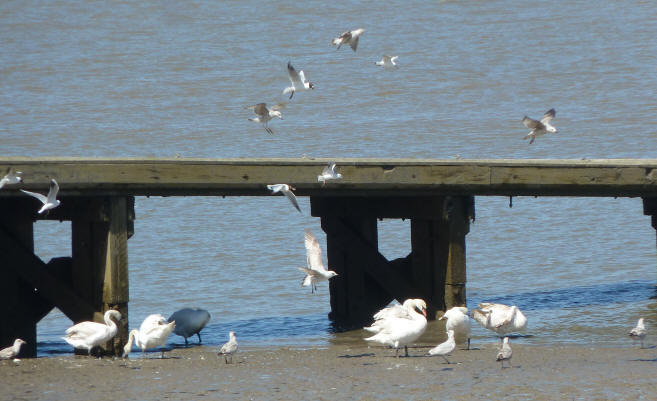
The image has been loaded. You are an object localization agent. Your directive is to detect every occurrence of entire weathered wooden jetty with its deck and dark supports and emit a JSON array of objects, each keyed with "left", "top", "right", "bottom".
[{"left": 0, "top": 157, "right": 657, "bottom": 356}]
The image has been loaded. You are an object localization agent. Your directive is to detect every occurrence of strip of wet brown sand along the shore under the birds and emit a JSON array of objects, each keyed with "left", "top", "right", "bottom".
[{"left": 0, "top": 342, "right": 657, "bottom": 401}]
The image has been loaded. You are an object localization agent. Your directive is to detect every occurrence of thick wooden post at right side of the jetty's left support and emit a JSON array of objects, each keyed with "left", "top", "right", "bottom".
[{"left": 72, "top": 197, "right": 134, "bottom": 355}]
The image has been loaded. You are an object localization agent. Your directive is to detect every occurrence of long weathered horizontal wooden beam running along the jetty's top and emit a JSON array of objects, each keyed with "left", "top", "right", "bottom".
[{"left": 0, "top": 157, "right": 657, "bottom": 197}]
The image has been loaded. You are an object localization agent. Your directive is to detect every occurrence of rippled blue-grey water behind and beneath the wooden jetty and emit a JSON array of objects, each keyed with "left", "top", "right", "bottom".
[{"left": 0, "top": 0, "right": 657, "bottom": 355}]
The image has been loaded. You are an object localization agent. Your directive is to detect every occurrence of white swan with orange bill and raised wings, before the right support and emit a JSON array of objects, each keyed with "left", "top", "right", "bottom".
[{"left": 365, "top": 299, "right": 427, "bottom": 356}]
